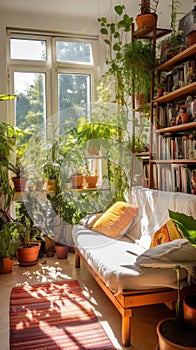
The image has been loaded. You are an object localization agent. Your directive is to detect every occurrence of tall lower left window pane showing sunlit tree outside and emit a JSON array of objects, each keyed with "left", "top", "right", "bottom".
[{"left": 14, "top": 72, "right": 46, "bottom": 134}]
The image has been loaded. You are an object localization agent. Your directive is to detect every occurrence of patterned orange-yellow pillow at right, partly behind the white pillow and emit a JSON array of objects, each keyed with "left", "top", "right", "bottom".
[{"left": 150, "top": 220, "right": 183, "bottom": 248}]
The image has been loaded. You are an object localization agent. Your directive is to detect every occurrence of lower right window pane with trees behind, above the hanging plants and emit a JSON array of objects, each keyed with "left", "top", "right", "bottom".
[{"left": 58, "top": 74, "right": 90, "bottom": 118}]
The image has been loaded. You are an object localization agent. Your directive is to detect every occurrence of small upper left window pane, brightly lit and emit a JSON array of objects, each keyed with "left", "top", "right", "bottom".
[{"left": 10, "top": 39, "right": 46, "bottom": 61}]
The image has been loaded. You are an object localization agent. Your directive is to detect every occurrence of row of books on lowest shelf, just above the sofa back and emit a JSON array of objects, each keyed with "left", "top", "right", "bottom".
[{"left": 153, "top": 164, "right": 196, "bottom": 193}]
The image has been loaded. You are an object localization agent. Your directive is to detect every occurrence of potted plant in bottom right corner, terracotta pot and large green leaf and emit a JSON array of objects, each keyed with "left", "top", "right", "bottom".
[{"left": 157, "top": 210, "right": 196, "bottom": 350}]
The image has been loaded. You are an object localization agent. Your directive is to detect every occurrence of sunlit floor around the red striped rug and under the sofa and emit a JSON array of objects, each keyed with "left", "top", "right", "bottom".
[{"left": 0, "top": 253, "right": 174, "bottom": 350}]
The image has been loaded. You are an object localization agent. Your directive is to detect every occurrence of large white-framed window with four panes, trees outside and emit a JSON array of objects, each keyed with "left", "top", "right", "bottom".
[{"left": 7, "top": 30, "right": 96, "bottom": 134}]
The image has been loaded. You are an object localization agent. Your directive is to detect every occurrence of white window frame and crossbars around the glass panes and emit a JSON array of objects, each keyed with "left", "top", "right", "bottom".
[{"left": 6, "top": 29, "right": 98, "bottom": 124}]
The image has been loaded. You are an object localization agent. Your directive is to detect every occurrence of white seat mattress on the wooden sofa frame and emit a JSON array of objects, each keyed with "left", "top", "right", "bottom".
[{"left": 73, "top": 225, "right": 191, "bottom": 294}]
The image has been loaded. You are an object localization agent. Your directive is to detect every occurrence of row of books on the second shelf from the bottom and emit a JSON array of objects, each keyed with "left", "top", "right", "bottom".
[{"left": 155, "top": 135, "right": 196, "bottom": 160}]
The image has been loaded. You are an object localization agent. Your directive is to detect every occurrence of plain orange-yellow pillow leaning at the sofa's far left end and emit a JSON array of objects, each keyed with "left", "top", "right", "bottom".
[{"left": 92, "top": 201, "right": 138, "bottom": 238}]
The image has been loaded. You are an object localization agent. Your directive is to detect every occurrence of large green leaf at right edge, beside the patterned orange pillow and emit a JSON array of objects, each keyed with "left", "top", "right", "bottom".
[{"left": 169, "top": 210, "right": 196, "bottom": 246}]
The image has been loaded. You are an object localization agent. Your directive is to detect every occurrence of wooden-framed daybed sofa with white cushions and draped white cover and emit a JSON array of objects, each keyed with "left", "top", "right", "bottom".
[{"left": 73, "top": 187, "right": 196, "bottom": 346}]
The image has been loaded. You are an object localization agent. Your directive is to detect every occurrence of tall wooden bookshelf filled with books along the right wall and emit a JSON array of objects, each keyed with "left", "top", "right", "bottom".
[{"left": 149, "top": 44, "right": 196, "bottom": 194}]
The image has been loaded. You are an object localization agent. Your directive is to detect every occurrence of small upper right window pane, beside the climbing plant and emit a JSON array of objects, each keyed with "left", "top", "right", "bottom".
[{"left": 56, "top": 41, "right": 92, "bottom": 64}]
